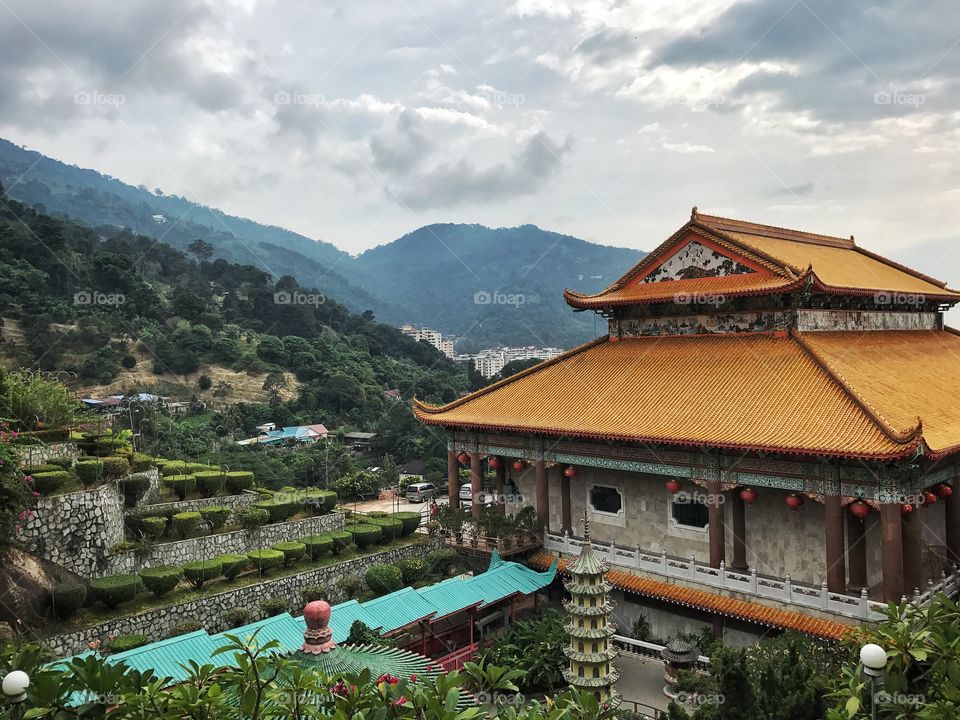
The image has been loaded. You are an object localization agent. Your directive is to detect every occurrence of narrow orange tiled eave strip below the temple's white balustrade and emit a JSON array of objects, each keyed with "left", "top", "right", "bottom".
[{"left": 527, "top": 553, "right": 854, "bottom": 640}]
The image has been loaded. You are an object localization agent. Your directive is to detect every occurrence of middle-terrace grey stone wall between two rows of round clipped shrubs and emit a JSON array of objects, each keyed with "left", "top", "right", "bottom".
[{"left": 103, "top": 512, "right": 344, "bottom": 575}]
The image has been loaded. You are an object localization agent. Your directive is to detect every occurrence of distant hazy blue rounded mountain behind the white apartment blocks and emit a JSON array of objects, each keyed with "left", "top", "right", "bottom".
[{"left": 356, "top": 224, "right": 644, "bottom": 352}]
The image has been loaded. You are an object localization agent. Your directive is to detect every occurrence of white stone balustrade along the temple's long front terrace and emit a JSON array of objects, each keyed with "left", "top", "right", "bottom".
[{"left": 543, "top": 533, "right": 886, "bottom": 620}]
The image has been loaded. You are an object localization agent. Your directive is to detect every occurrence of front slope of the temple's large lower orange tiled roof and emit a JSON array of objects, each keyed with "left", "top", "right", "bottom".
[{"left": 414, "top": 333, "right": 924, "bottom": 459}]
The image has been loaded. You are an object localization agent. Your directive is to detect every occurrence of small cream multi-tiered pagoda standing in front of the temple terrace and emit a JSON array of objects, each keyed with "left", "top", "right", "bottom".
[{"left": 563, "top": 516, "right": 621, "bottom": 707}]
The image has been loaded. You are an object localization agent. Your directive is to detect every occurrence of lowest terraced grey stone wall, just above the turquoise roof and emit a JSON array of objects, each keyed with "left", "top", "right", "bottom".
[{"left": 45, "top": 540, "right": 441, "bottom": 657}]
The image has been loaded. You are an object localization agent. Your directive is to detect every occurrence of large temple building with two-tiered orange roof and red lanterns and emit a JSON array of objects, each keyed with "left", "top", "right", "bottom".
[{"left": 414, "top": 208, "right": 960, "bottom": 636}]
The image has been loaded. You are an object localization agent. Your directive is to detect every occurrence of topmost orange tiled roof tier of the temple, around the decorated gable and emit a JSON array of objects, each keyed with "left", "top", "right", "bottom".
[{"left": 564, "top": 213, "right": 960, "bottom": 309}]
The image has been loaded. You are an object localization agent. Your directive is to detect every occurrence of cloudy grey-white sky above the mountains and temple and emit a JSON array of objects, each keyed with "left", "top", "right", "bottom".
[{"left": 0, "top": 0, "right": 960, "bottom": 278}]
